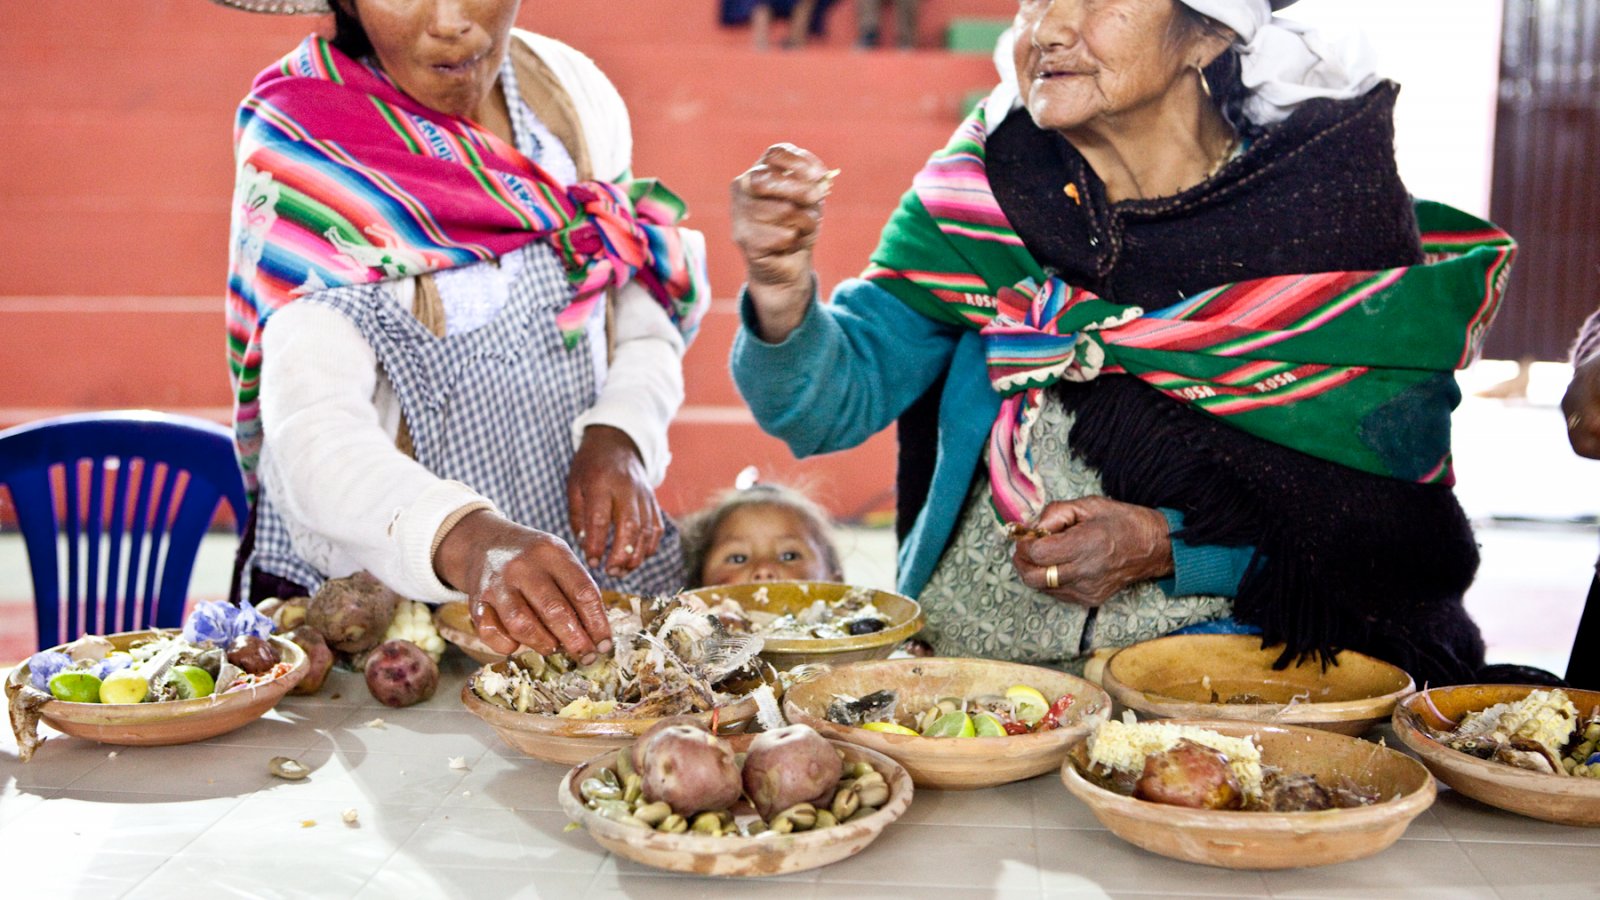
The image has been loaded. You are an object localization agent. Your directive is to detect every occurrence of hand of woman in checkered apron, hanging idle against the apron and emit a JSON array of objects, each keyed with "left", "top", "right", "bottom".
[{"left": 566, "top": 424, "right": 662, "bottom": 578}]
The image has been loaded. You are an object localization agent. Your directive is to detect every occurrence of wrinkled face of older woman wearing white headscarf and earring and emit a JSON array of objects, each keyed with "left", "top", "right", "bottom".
[{"left": 1014, "top": 0, "right": 1222, "bottom": 131}]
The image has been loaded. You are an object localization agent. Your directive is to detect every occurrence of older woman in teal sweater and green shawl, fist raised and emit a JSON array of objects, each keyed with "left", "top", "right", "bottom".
[{"left": 733, "top": 0, "right": 1512, "bottom": 682}]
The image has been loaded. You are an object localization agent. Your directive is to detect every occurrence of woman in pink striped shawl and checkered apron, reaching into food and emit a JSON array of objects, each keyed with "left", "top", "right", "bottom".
[{"left": 222, "top": 0, "right": 706, "bottom": 660}]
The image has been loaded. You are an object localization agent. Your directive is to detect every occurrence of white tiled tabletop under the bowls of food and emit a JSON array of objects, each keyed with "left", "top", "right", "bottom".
[{"left": 0, "top": 652, "right": 1600, "bottom": 900}]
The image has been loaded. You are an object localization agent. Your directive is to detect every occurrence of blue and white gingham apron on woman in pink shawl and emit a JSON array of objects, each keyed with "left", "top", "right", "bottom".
[{"left": 253, "top": 243, "right": 683, "bottom": 594}]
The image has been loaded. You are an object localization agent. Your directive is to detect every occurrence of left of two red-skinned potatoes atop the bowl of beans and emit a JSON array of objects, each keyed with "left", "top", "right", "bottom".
[{"left": 634, "top": 722, "right": 739, "bottom": 818}]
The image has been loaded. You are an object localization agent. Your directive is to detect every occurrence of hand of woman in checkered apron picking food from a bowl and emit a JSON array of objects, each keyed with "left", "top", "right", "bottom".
[{"left": 434, "top": 509, "right": 611, "bottom": 665}]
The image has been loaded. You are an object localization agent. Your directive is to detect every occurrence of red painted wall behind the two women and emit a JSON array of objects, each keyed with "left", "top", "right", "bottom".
[{"left": 0, "top": 0, "right": 1014, "bottom": 516}]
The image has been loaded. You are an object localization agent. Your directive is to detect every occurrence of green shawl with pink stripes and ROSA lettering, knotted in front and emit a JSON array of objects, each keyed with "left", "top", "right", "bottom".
[{"left": 862, "top": 107, "right": 1515, "bottom": 522}]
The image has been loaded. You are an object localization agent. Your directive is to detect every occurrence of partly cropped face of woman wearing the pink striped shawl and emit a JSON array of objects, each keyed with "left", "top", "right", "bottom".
[{"left": 344, "top": 0, "right": 522, "bottom": 119}]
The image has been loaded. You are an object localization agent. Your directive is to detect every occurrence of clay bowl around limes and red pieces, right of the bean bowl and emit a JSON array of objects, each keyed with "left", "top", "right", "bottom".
[{"left": 784, "top": 658, "right": 1110, "bottom": 790}]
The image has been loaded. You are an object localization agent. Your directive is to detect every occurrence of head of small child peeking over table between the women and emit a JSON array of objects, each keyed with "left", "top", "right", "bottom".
[{"left": 683, "top": 484, "right": 845, "bottom": 588}]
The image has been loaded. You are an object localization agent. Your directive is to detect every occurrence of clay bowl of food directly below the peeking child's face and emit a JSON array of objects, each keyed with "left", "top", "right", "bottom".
[{"left": 675, "top": 581, "right": 923, "bottom": 671}]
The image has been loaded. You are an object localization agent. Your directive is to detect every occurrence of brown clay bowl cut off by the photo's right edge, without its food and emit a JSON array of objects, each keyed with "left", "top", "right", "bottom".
[{"left": 1394, "top": 684, "right": 1600, "bottom": 826}]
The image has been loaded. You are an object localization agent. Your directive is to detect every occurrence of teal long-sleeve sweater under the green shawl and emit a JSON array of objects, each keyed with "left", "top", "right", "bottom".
[{"left": 730, "top": 280, "right": 1254, "bottom": 597}]
